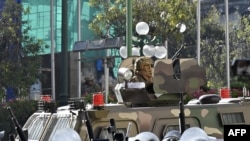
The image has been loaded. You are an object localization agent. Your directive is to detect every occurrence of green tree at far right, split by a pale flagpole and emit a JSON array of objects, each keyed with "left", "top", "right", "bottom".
[{"left": 201, "top": 6, "right": 250, "bottom": 88}]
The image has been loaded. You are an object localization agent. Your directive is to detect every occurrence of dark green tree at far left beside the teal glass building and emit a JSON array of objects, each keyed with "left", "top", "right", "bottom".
[{"left": 0, "top": 0, "right": 43, "bottom": 98}]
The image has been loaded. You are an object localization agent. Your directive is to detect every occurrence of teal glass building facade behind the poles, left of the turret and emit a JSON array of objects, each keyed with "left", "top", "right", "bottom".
[{"left": 22, "top": 0, "right": 105, "bottom": 97}]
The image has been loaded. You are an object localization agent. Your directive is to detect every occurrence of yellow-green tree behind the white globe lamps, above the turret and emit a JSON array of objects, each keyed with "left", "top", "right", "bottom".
[{"left": 89, "top": 0, "right": 195, "bottom": 54}]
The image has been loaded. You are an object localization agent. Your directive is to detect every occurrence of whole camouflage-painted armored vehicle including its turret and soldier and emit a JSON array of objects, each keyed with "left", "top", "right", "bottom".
[{"left": 8, "top": 57, "right": 250, "bottom": 141}]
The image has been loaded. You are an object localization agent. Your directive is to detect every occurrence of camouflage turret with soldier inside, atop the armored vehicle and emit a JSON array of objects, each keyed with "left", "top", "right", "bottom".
[{"left": 116, "top": 56, "right": 206, "bottom": 105}]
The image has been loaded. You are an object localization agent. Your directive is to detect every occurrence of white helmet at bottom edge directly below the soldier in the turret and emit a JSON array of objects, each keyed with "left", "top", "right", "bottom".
[{"left": 129, "top": 132, "right": 160, "bottom": 141}]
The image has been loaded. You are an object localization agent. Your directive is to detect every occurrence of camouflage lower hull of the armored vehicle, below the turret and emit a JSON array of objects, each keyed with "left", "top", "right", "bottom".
[{"left": 16, "top": 98, "right": 250, "bottom": 141}]
